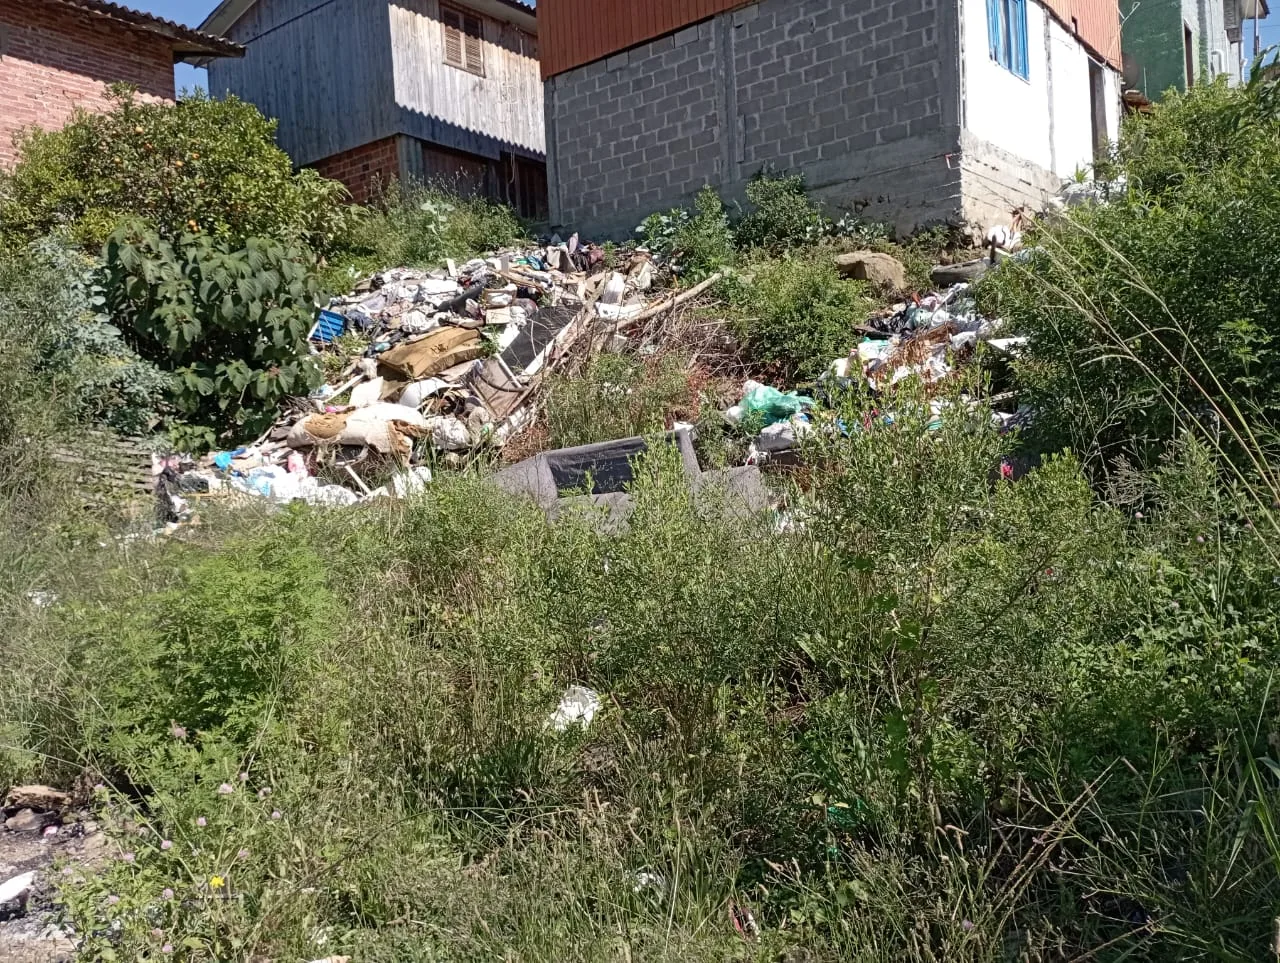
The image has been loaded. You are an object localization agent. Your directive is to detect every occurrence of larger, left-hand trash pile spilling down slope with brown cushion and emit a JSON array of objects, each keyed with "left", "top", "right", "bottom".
[{"left": 152, "top": 234, "right": 696, "bottom": 525}]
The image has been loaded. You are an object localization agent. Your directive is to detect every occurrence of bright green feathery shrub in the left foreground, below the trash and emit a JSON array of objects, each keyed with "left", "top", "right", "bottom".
[{"left": 65, "top": 519, "right": 335, "bottom": 758}]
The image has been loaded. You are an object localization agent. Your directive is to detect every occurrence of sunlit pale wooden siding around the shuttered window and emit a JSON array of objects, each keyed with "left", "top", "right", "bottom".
[{"left": 390, "top": 0, "right": 547, "bottom": 159}]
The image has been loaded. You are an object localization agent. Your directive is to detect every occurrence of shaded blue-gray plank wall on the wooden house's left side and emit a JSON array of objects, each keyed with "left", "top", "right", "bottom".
[{"left": 209, "top": 0, "right": 398, "bottom": 165}]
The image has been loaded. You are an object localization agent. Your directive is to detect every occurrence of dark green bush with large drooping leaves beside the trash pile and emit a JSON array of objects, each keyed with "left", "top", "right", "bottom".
[{"left": 104, "top": 223, "right": 320, "bottom": 444}]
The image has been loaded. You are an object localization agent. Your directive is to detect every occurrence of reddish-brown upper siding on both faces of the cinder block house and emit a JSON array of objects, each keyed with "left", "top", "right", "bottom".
[{"left": 538, "top": 0, "right": 1120, "bottom": 78}]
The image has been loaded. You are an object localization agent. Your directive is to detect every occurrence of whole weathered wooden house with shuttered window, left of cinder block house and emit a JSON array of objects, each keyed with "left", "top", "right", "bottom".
[{"left": 201, "top": 0, "right": 547, "bottom": 218}]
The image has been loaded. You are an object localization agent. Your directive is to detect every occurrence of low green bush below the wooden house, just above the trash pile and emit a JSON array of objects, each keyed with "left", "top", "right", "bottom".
[{"left": 326, "top": 182, "right": 525, "bottom": 285}]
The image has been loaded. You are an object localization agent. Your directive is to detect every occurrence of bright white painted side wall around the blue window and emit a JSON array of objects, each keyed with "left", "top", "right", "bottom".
[{"left": 961, "top": 0, "right": 1120, "bottom": 178}]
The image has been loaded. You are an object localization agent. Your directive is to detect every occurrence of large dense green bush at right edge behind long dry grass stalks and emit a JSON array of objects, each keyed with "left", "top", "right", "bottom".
[{"left": 984, "top": 74, "right": 1280, "bottom": 464}]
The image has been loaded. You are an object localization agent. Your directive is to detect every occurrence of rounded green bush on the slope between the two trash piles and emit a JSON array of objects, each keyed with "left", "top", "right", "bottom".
[{"left": 730, "top": 257, "right": 868, "bottom": 382}]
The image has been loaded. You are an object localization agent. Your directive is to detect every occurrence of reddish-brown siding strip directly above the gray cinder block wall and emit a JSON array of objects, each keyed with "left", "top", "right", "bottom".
[{"left": 538, "top": 0, "right": 746, "bottom": 78}]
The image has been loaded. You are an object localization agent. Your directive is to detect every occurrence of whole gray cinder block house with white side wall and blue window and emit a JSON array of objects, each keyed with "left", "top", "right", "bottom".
[{"left": 538, "top": 0, "right": 1121, "bottom": 236}]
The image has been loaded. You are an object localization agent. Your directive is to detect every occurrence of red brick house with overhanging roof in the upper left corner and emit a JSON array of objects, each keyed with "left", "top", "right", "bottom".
[{"left": 0, "top": 0, "right": 244, "bottom": 168}]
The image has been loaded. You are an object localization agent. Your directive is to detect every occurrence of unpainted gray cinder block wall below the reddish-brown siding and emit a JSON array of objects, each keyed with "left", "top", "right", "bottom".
[{"left": 545, "top": 0, "right": 960, "bottom": 236}]
